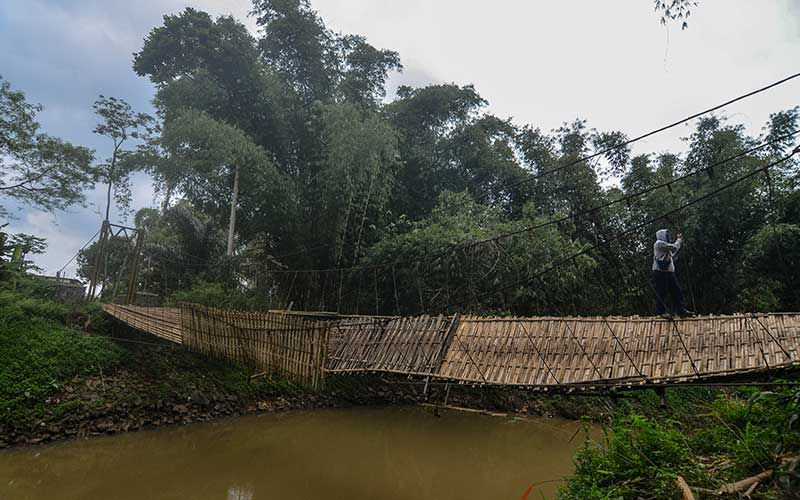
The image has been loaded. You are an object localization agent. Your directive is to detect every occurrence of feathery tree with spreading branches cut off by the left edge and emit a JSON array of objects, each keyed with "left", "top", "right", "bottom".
[{"left": 0, "top": 78, "right": 93, "bottom": 216}]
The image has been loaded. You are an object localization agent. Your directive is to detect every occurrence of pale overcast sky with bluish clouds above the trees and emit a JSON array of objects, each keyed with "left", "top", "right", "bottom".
[{"left": 0, "top": 0, "right": 800, "bottom": 273}]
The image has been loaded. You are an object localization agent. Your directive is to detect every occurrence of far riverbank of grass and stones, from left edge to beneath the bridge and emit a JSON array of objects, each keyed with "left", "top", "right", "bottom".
[{"left": 0, "top": 292, "right": 676, "bottom": 448}]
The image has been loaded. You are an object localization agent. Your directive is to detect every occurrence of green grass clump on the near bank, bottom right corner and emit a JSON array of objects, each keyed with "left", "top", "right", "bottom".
[{"left": 560, "top": 387, "right": 800, "bottom": 500}]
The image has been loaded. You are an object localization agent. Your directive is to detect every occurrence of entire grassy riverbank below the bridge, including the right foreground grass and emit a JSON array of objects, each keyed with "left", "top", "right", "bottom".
[{"left": 0, "top": 292, "right": 800, "bottom": 499}]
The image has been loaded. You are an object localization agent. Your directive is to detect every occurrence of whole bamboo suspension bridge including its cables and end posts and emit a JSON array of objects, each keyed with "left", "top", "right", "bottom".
[{"left": 90, "top": 73, "right": 800, "bottom": 389}]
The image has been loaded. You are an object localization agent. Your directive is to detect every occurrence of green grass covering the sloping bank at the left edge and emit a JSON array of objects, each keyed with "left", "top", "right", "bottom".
[{"left": 0, "top": 289, "right": 301, "bottom": 427}]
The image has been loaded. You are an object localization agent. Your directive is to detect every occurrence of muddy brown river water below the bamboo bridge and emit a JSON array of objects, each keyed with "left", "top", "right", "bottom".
[{"left": 0, "top": 407, "right": 583, "bottom": 500}]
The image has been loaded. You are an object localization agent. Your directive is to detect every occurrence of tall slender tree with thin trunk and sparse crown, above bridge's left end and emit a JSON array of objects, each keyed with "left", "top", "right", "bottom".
[{"left": 94, "top": 95, "right": 153, "bottom": 221}]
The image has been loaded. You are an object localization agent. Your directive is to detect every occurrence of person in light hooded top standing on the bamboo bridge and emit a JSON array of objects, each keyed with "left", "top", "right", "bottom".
[{"left": 653, "top": 229, "right": 694, "bottom": 318}]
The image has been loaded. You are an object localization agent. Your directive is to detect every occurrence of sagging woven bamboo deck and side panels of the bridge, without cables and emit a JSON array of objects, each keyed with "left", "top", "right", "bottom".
[{"left": 104, "top": 304, "right": 800, "bottom": 389}]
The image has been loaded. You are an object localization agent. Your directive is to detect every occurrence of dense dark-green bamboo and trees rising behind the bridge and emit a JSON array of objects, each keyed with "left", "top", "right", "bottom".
[{"left": 53, "top": 0, "right": 800, "bottom": 314}]
